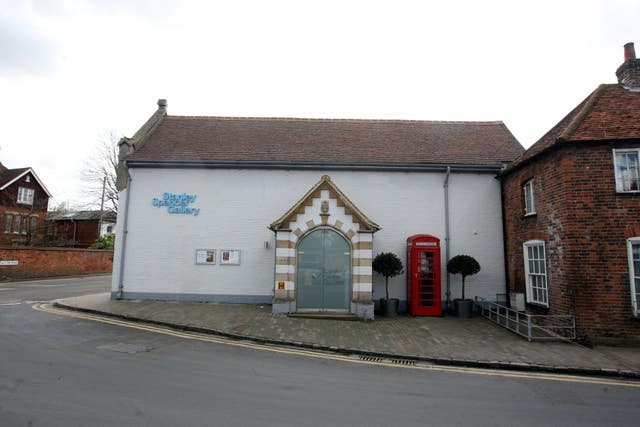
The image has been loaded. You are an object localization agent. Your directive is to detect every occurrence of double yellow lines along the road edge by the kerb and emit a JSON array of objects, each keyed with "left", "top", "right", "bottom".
[{"left": 32, "top": 304, "right": 640, "bottom": 388}]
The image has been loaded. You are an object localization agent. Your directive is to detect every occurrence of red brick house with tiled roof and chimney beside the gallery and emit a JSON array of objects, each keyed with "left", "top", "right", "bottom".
[{"left": 501, "top": 43, "right": 640, "bottom": 337}]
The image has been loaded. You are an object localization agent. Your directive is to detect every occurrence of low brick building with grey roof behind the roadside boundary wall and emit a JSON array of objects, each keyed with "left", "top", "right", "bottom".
[{"left": 46, "top": 211, "right": 116, "bottom": 248}]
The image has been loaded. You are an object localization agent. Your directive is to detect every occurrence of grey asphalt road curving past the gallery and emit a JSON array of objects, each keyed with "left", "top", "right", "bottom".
[{"left": 0, "top": 276, "right": 640, "bottom": 426}]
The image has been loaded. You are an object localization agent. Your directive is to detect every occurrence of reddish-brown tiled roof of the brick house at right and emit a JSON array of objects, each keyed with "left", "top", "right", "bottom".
[{"left": 508, "top": 84, "right": 640, "bottom": 170}]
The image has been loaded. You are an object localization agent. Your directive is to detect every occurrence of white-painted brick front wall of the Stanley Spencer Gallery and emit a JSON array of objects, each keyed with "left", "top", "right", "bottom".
[{"left": 113, "top": 168, "right": 504, "bottom": 299}]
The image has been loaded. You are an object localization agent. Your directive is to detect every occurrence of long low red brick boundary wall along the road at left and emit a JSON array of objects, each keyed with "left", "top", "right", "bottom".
[{"left": 0, "top": 247, "right": 113, "bottom": 280}]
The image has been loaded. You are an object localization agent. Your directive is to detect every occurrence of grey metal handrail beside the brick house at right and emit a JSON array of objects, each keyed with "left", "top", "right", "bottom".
[{"left": 475, "top": 297, "right": 576, "bottom": 342}]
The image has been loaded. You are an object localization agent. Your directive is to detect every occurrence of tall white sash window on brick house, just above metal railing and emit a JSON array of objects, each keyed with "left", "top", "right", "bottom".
[{"left": 523, "top": 240, "right": 549, "bottom": 307}]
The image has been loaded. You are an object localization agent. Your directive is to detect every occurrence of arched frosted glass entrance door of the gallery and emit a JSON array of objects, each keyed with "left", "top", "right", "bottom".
[{"left": 296, "top": 228, "right": 351, "bottom": 311}]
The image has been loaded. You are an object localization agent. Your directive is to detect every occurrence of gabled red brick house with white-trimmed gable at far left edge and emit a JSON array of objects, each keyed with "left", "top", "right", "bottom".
[{"left": 0, "top": 163, "right": 51, "bottom": 246}]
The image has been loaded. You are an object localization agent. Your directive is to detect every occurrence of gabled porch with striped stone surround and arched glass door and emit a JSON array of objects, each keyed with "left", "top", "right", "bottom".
[{"left": 269, "top": 175, "right": 380, "bottom": 319}]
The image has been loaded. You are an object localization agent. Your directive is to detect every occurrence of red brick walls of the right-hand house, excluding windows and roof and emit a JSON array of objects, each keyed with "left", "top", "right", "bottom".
[{"left": 503, "top": 143, "right": 640, "bottom": 336}]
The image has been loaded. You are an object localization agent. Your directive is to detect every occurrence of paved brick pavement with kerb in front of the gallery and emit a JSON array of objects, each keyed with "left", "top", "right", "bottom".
[{"left": 54, "top": 293, "right": 640, "bottom": 379}]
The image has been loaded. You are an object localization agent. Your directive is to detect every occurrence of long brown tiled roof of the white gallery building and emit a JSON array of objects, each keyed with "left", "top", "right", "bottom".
[{"left": 128, "top": 116, "right": 523, "bottom": 166}]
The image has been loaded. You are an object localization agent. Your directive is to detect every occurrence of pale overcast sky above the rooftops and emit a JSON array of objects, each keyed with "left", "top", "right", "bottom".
[{"left": 0, "top": 0, "right": 640, "bottom": 209}]
